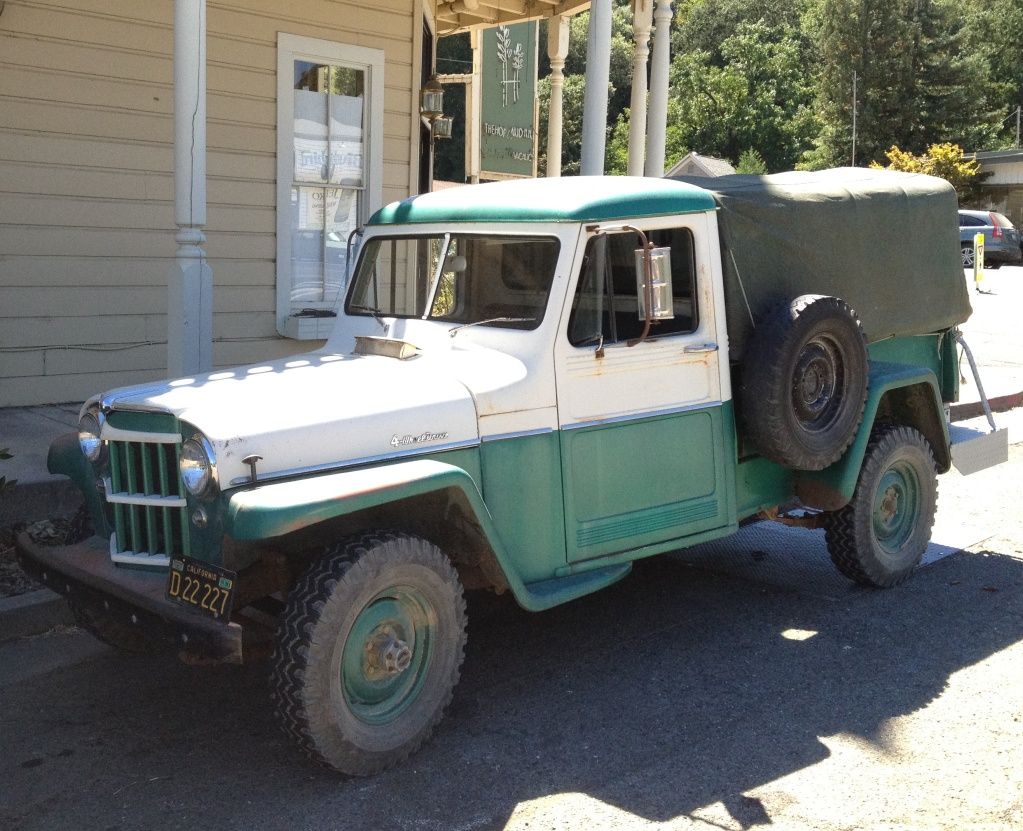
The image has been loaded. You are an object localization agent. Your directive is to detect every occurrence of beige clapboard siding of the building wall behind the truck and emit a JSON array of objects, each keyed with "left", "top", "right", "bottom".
[{"left": 0, "top": 0, "right": 421, "bottom": 406}]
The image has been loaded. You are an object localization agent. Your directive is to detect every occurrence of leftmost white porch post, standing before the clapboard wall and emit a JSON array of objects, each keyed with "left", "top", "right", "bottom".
[{"left": 167, "top": 0, "right": 213, "bottom": 378}]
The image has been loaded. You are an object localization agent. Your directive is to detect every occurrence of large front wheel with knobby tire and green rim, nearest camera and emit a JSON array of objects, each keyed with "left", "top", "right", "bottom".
[{"left": 271, "top": 531, "right": 465, "bottom": 776}]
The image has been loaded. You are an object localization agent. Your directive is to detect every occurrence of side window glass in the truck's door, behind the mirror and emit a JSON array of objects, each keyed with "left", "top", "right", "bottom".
[{"left": 569, "top": 228, "right": 699, "bottom": 346}]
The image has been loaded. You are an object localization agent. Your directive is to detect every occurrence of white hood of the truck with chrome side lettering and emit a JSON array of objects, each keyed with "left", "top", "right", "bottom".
[{"left": 102, "top": 352, "right": 479, "bottom": 488}]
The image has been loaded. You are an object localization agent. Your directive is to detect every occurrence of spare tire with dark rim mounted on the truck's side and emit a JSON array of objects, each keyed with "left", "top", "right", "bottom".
[{"left": 740, "top": 295, "right": 868, "bottom": 471}]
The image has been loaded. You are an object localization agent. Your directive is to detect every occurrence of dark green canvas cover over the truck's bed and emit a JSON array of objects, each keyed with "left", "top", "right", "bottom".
[{"left": 677, "top": 168, "right": 972, "bottom": 360}]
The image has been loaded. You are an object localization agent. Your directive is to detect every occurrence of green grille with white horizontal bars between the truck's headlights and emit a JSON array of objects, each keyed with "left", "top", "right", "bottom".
[{"left": 105, "top": 433, "right": 189, "bottom": 566}]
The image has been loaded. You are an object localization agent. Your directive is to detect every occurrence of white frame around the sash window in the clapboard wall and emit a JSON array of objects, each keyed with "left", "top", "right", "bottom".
[{"left": 274, "top": 32, "right": 385, "bottom": 340}]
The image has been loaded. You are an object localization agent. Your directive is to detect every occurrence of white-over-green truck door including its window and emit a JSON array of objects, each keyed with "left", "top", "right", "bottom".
[{"left": 554, "top": 220, "right": 727, "bottom": 563}]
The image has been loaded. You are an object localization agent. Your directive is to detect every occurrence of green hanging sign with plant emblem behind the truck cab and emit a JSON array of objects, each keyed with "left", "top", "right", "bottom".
[{"left": 480, "top": 20, "right": 537, "bottom": 179}]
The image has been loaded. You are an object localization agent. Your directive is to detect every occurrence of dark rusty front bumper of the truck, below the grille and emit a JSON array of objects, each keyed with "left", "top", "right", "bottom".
[{"left": 16, "top": 533, "right": 242, "bottom": 663}]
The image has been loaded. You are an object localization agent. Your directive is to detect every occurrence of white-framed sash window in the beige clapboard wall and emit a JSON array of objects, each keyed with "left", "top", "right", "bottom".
[{"left": 277, "top": 34, "right": 384, "bottom": 338}]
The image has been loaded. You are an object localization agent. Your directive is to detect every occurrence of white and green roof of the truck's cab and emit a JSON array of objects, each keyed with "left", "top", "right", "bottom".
[{"left": 369, "top": 176, "right": 715, "bottom": 225}]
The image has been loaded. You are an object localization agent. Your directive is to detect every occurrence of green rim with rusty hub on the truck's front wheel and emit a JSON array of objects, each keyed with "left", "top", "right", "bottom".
[{"left": 341, "top": 586, "right": 437, "bottom": 725}]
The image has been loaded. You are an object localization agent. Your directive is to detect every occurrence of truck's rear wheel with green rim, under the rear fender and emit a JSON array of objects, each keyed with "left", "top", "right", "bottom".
[{"left": 826, "top": 426, "right": 938, "bottom": 588}]
